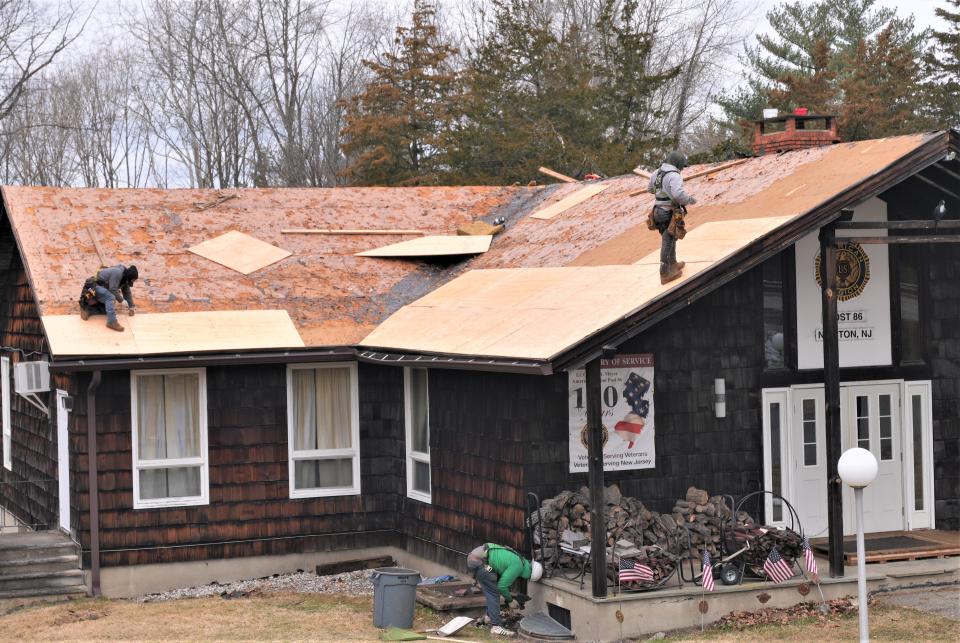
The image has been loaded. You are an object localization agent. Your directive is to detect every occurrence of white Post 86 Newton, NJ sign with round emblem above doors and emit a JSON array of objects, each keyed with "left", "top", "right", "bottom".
[{"left": 795, "top": 199, "right": 892, "bottom": 369}]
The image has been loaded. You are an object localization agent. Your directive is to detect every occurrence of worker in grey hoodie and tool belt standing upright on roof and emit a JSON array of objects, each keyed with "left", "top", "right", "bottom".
[{"left": 647, "top": 150, "right": 697, "bottom": 284}]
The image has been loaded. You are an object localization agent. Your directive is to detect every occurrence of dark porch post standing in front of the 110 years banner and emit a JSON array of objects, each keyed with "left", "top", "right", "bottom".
[{"left": 586, "top": 357, "right": 607, "bottom": 598}]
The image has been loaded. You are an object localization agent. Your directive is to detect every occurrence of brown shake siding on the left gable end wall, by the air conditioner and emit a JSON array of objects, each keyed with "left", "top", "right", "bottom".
[{"left": 0, "top": 215, "right": 67, "bottom": 529}]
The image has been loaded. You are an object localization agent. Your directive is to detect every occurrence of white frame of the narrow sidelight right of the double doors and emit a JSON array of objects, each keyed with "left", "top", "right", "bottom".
[{"left": 900, "top": 380, "right": 936, "bottom": 529}]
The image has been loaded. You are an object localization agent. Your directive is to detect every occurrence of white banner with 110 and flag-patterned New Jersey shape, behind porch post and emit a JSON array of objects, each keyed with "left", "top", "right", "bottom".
[{"left": 569, "top": 354, "right": 656, "bottom": 473}]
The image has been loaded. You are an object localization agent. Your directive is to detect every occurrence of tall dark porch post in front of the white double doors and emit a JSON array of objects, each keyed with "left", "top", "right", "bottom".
[{"left": 820, "top": 224, "right": 843, "bottom": 578}]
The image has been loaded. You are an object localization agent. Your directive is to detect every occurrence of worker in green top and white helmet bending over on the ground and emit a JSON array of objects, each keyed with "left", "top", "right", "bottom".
[{"left": 467, "top": 543, "right": 543, "bottom": 636}]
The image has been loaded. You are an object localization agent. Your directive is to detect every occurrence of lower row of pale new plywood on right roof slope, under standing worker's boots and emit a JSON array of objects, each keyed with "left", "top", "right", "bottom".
[{"left": 362, "top": 263, "right": 710, "bottom": 359}]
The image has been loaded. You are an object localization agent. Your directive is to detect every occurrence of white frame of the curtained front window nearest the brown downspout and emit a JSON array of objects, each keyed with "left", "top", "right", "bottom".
[{"left": 130, "top": 368, "right": 210, "bottom": 509}]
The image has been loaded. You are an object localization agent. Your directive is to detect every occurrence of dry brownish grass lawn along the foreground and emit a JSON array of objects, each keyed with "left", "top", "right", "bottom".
[{"left": 0, "top": 593, "right": 960, "bottom": 643}]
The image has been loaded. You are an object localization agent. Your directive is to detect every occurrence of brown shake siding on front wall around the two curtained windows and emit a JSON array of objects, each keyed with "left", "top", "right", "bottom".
[{"left": 74, "top": 364, "right": 403, "bottom": 566}]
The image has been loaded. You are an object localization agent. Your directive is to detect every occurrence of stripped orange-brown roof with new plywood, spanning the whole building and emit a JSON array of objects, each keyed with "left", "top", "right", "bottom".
[{"left": 3, "top": 132, "right": 955, "bottom": 365}]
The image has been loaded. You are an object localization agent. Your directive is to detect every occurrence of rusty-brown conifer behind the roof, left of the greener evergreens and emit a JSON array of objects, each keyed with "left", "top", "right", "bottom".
[{"left": 342, "top": 0, "right": 460, "bottom": 185}]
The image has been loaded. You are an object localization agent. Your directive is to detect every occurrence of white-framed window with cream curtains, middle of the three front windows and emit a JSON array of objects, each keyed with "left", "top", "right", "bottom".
[{"left": 287, "top": 364, "right": 360, "bottom": 498}]
